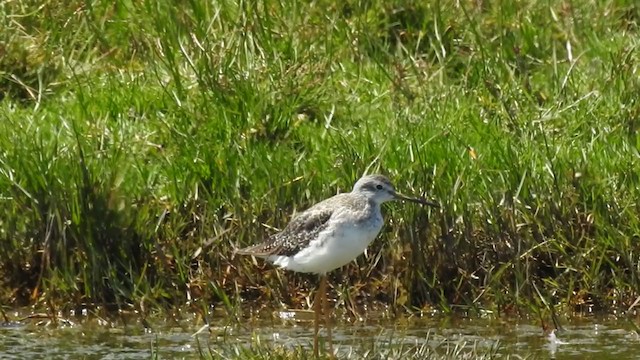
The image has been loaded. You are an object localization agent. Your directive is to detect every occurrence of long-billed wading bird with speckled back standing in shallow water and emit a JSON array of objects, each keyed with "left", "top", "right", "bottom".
[{"left": 236, "top": 175, "right": 439, "bottom": 357}]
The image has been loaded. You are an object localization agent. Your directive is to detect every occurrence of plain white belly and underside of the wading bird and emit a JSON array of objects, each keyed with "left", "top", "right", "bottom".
[{"left": 268, "top": 216, "right": 382, "bottom": 274}]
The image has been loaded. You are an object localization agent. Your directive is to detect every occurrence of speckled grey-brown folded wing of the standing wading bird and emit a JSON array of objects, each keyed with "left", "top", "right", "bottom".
[{"left": 236, "top": 208, "right": 333, "bottom": 257}]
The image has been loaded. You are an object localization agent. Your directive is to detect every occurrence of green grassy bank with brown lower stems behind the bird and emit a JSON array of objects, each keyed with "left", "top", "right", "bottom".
[{"left": 0, "top": 0, "right": 640, "bottom": 318}]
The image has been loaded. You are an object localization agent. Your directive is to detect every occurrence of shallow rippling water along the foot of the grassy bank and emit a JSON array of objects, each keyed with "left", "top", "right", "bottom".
[{"left": 0, "top": 313, "right": 640, "bottom": 360}]
